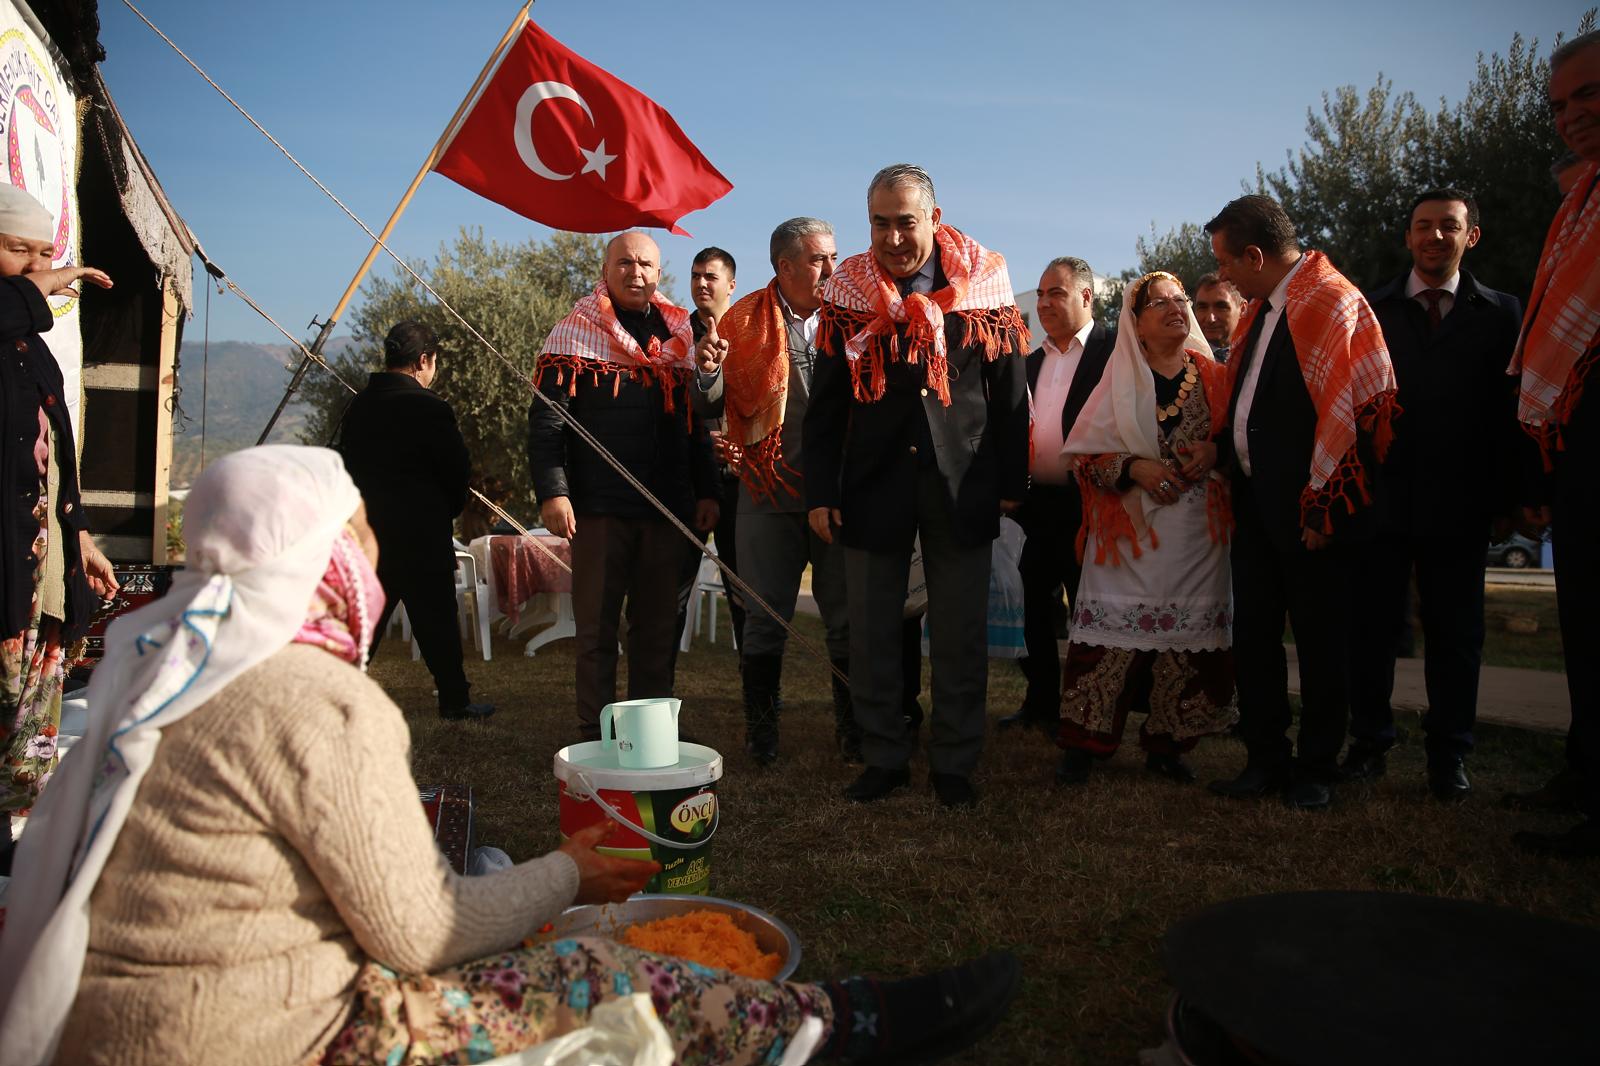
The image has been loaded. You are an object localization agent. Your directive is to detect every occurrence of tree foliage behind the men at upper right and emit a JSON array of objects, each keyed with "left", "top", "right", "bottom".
[{"left": 1134, "top": 10, "right": 1595, "bottom": 296}]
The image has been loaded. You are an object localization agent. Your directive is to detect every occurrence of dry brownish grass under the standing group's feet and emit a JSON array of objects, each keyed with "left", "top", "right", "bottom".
[{"left": 373, "top": 605, "right": 1600, "bottom": 1064}]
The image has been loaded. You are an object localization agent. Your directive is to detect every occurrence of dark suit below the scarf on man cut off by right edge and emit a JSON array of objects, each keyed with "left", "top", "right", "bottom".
[{"left": 1550, "top": 356, "right": 1600, "bottom": 818}]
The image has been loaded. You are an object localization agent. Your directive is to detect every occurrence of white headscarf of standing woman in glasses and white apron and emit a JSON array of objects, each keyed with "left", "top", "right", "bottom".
[{"left": 1061, "top": 271, "right": 1211, "bottom": 520}]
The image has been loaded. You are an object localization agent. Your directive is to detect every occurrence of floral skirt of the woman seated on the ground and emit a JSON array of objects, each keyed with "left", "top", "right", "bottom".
[{"left": 320, "top": 938, "right": 832, "bottom": 1066}]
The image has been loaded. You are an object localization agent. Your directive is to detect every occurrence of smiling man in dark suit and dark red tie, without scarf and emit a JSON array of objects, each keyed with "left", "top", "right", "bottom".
[{"left": 1342, "top": 189, "right": 1533, "bottom": 800}]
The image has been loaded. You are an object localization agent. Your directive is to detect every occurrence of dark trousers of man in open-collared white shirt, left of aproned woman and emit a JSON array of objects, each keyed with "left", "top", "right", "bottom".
[{"left": 1018, "top": 485, "right": 1083, "bottom": 722}]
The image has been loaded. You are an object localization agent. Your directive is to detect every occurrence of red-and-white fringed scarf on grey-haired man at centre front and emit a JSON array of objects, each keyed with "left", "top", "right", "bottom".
[{"left": 818, "top": 226, "right": 1027, "bottom": 407}]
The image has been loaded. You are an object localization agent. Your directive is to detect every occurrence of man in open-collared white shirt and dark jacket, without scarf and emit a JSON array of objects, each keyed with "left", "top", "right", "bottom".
[{"left": 998, "top": 256, "right": 1117, "bottom": 736}]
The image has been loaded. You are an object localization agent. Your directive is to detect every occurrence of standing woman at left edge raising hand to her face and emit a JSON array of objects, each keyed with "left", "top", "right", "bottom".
[{"left": 0, "top": 182, "right": 117, "bottom": 872}]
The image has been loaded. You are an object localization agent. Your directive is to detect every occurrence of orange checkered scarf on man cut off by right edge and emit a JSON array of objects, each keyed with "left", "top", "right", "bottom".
[{"left": 1510, "top": 163, "right": 1600, "bottom": 466}]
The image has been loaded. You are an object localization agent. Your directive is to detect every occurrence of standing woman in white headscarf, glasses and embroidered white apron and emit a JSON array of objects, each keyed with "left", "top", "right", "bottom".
[{"left": 1056, "top": 271, "right": 1235, "bottom": 784}]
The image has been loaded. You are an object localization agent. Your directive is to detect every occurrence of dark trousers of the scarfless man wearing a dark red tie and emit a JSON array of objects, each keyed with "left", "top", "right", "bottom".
[{"left": 1350, "top": 522, "right": 1488, "bottom": 757}]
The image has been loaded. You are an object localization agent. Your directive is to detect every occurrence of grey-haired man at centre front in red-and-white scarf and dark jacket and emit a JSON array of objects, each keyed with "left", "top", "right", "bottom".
[{"left": 803, "top": 163, "right": 1027, "bottom": 807}]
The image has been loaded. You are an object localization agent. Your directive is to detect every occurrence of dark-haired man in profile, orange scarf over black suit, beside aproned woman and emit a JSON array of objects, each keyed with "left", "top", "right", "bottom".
[{"left": 1205, "top": 195, "right": 1394, "bottom": 808}]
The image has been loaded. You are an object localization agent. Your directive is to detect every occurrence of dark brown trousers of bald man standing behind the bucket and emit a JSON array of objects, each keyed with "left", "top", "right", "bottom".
[{"left": 573, "top": 514, "right": 685, "bottom": 736}]
